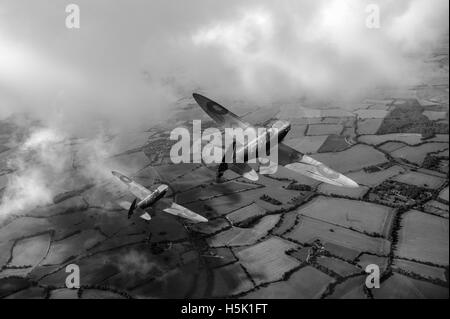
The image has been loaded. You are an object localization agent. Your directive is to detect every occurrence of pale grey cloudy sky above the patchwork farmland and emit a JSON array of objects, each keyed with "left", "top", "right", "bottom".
[{"left": 0, "top": 0, "right": 448, "bottom": 134}]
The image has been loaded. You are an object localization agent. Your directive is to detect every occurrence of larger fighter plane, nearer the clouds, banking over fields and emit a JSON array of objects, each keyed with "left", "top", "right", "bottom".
[{"left": 193, "top": 93, "right": 359, "bottom": 188}]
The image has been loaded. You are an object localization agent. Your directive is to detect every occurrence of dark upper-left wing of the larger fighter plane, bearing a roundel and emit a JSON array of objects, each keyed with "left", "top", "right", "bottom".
[{"left": 193, "top": 93, "right": 252, "bottom": 130}]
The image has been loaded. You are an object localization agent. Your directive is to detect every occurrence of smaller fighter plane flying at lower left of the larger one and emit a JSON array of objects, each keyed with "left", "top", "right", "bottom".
[{"left": 112, "top": 171, "right": 208, "bottom": 223}]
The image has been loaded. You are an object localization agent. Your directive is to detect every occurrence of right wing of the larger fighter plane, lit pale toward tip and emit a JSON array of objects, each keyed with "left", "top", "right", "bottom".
[{"left": 278, "top": 143, "right": 358, "bottom": 188}]
